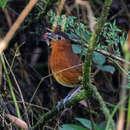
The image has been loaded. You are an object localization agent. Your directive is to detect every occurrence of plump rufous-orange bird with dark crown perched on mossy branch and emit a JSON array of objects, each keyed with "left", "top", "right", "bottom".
[{"left": 43, "top": 31, "right": 82, "bottom": 88}]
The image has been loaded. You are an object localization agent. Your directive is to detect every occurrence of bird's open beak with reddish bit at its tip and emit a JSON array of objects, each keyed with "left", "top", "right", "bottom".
[{"left": 41, "top": 32, "right": 55, "bottom": 46}]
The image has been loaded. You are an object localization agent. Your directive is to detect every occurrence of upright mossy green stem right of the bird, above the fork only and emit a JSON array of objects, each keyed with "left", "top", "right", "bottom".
[{"left": 82, "top": 0, "right": 112, "bottom": 93}]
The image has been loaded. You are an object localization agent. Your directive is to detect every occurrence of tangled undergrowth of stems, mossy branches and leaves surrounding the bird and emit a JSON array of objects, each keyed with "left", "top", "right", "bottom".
[{"left": 0, "top": 0, "right": 130, "bottom": 130}]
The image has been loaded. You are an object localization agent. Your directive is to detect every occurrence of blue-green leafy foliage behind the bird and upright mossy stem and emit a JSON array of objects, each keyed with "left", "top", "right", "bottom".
[{"left": 48, "top": 10, "right": 126, "bottom": 73}]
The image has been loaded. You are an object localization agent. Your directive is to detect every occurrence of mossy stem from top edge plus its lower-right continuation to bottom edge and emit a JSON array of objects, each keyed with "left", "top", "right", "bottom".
[{"left": 82, "top": 0, "right": 115, "bottom": 130}]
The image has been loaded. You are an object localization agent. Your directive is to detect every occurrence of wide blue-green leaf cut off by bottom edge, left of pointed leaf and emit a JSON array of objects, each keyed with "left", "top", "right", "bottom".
[{"left": 59, "top": 124, "right": 87, "bottom": 130}]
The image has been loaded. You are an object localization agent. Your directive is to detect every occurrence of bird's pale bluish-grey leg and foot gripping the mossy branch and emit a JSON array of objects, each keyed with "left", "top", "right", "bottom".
[{"left": 56, "top": 87, "right": 81, "bottom": 110}]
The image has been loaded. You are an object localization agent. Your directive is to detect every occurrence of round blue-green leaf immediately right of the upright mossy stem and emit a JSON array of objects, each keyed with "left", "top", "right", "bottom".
[{"left": 92, "top": 52, "right": 106, "bottom": 65}]
